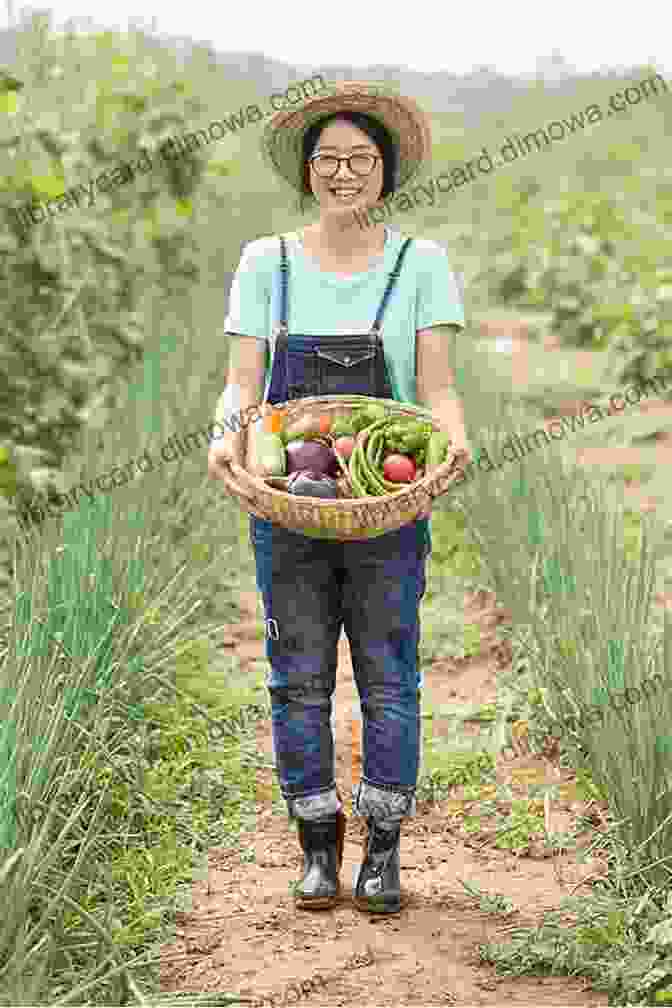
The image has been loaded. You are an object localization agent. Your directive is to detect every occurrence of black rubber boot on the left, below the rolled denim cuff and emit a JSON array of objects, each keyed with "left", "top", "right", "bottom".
[{"left": 294, "top": 809, "right": 346, "bottom": 910}]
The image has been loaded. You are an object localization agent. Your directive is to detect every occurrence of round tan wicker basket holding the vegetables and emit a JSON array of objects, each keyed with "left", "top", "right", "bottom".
[{"left": 218, "top": 395, "right": 459, "bottom": 541}]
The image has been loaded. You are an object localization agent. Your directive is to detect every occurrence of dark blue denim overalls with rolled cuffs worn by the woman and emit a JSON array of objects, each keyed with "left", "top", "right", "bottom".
[{"left": 250, "top": 238, "right": 431, "bottom": 827}]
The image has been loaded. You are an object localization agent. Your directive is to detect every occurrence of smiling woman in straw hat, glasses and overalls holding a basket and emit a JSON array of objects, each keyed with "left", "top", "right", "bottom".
[{"left": 209, "top": 82, "right": 466, "bottom": 912}]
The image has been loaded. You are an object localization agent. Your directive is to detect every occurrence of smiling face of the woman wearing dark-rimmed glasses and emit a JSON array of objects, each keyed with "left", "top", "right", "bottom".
[{"left": 309, "top": 119, "right": 383, "bottom": 216}]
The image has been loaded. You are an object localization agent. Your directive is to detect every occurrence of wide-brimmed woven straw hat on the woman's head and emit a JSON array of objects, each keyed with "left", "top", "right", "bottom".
[{"left": 261, "top": 81, "right": 431, "bottom": 193}]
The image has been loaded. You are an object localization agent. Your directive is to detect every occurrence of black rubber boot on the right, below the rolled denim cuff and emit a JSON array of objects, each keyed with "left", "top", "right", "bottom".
[{"left": 355, "top": 818, "right": 401, "bottom": 913}]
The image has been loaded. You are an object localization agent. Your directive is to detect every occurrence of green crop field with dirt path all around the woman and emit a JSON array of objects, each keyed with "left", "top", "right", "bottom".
[{"left": 0, "top": 16, "right": 672, "bottom": 1008}]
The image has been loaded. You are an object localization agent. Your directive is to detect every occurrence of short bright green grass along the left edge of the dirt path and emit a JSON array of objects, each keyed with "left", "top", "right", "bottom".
[{"left": 52, "top": 653, "right": 274, "bottom": 1000}]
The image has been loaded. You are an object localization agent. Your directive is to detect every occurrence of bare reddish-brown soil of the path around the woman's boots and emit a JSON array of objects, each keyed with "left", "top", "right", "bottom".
[{"left": 161, "top": 323, "right": 670, "bottom": 1008}]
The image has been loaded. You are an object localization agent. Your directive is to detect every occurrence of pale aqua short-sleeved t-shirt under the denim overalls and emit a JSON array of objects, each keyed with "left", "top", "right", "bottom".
[{"left": 224, "top": 228, "right": 464, "bottom": 411}]
